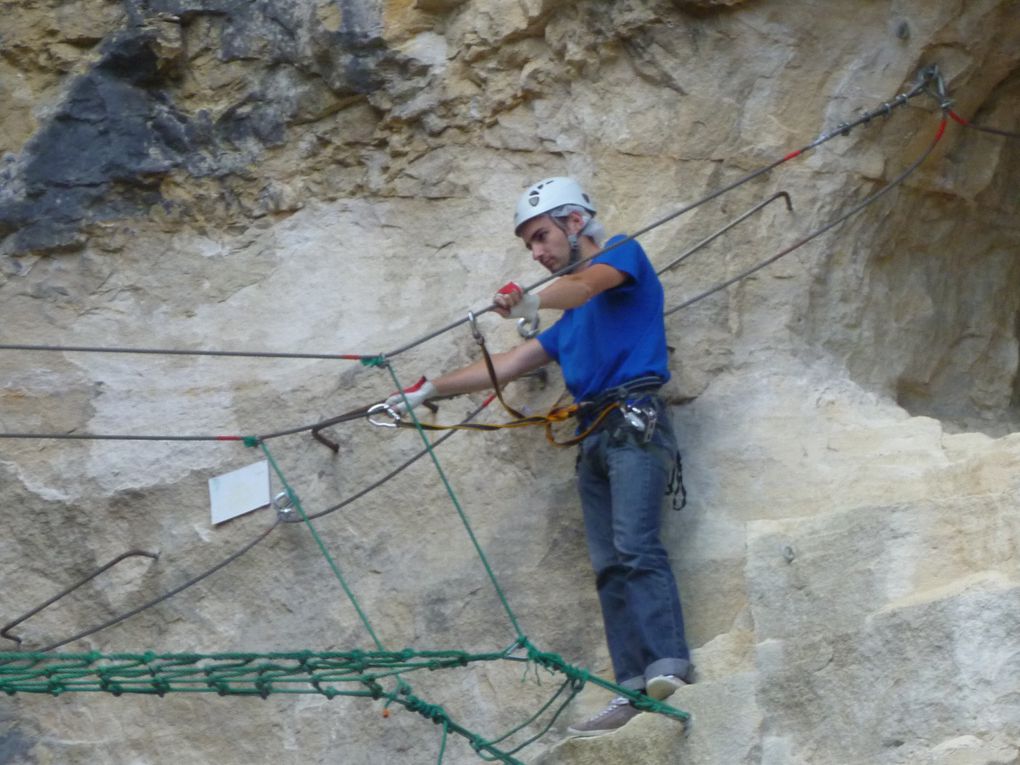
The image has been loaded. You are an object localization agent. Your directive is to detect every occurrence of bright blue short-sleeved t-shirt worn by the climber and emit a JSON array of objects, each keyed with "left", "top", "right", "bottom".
[{"left": 538, "top": 236, "right": 669, "bottom": 401}]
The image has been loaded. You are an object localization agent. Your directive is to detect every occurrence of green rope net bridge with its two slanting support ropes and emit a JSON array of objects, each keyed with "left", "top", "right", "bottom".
[{"left": 0, "top": 359, "right": 690, "bottom": 765}]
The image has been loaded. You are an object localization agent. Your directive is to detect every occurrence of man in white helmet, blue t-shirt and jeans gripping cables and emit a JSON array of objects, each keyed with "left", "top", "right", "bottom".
[{"left": 387, "top": 177, "right": 691, "bottom": 735}]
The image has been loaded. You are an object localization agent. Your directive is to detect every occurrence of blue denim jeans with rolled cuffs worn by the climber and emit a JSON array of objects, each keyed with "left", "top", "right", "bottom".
[{"left": 577, "top": 397, "right": 691, "bottom": 691}]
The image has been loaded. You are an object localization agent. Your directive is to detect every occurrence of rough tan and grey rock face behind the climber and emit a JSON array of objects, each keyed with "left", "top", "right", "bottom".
[{"left": 0, "top": 0, "right": 1020, "bottom": 765}]
